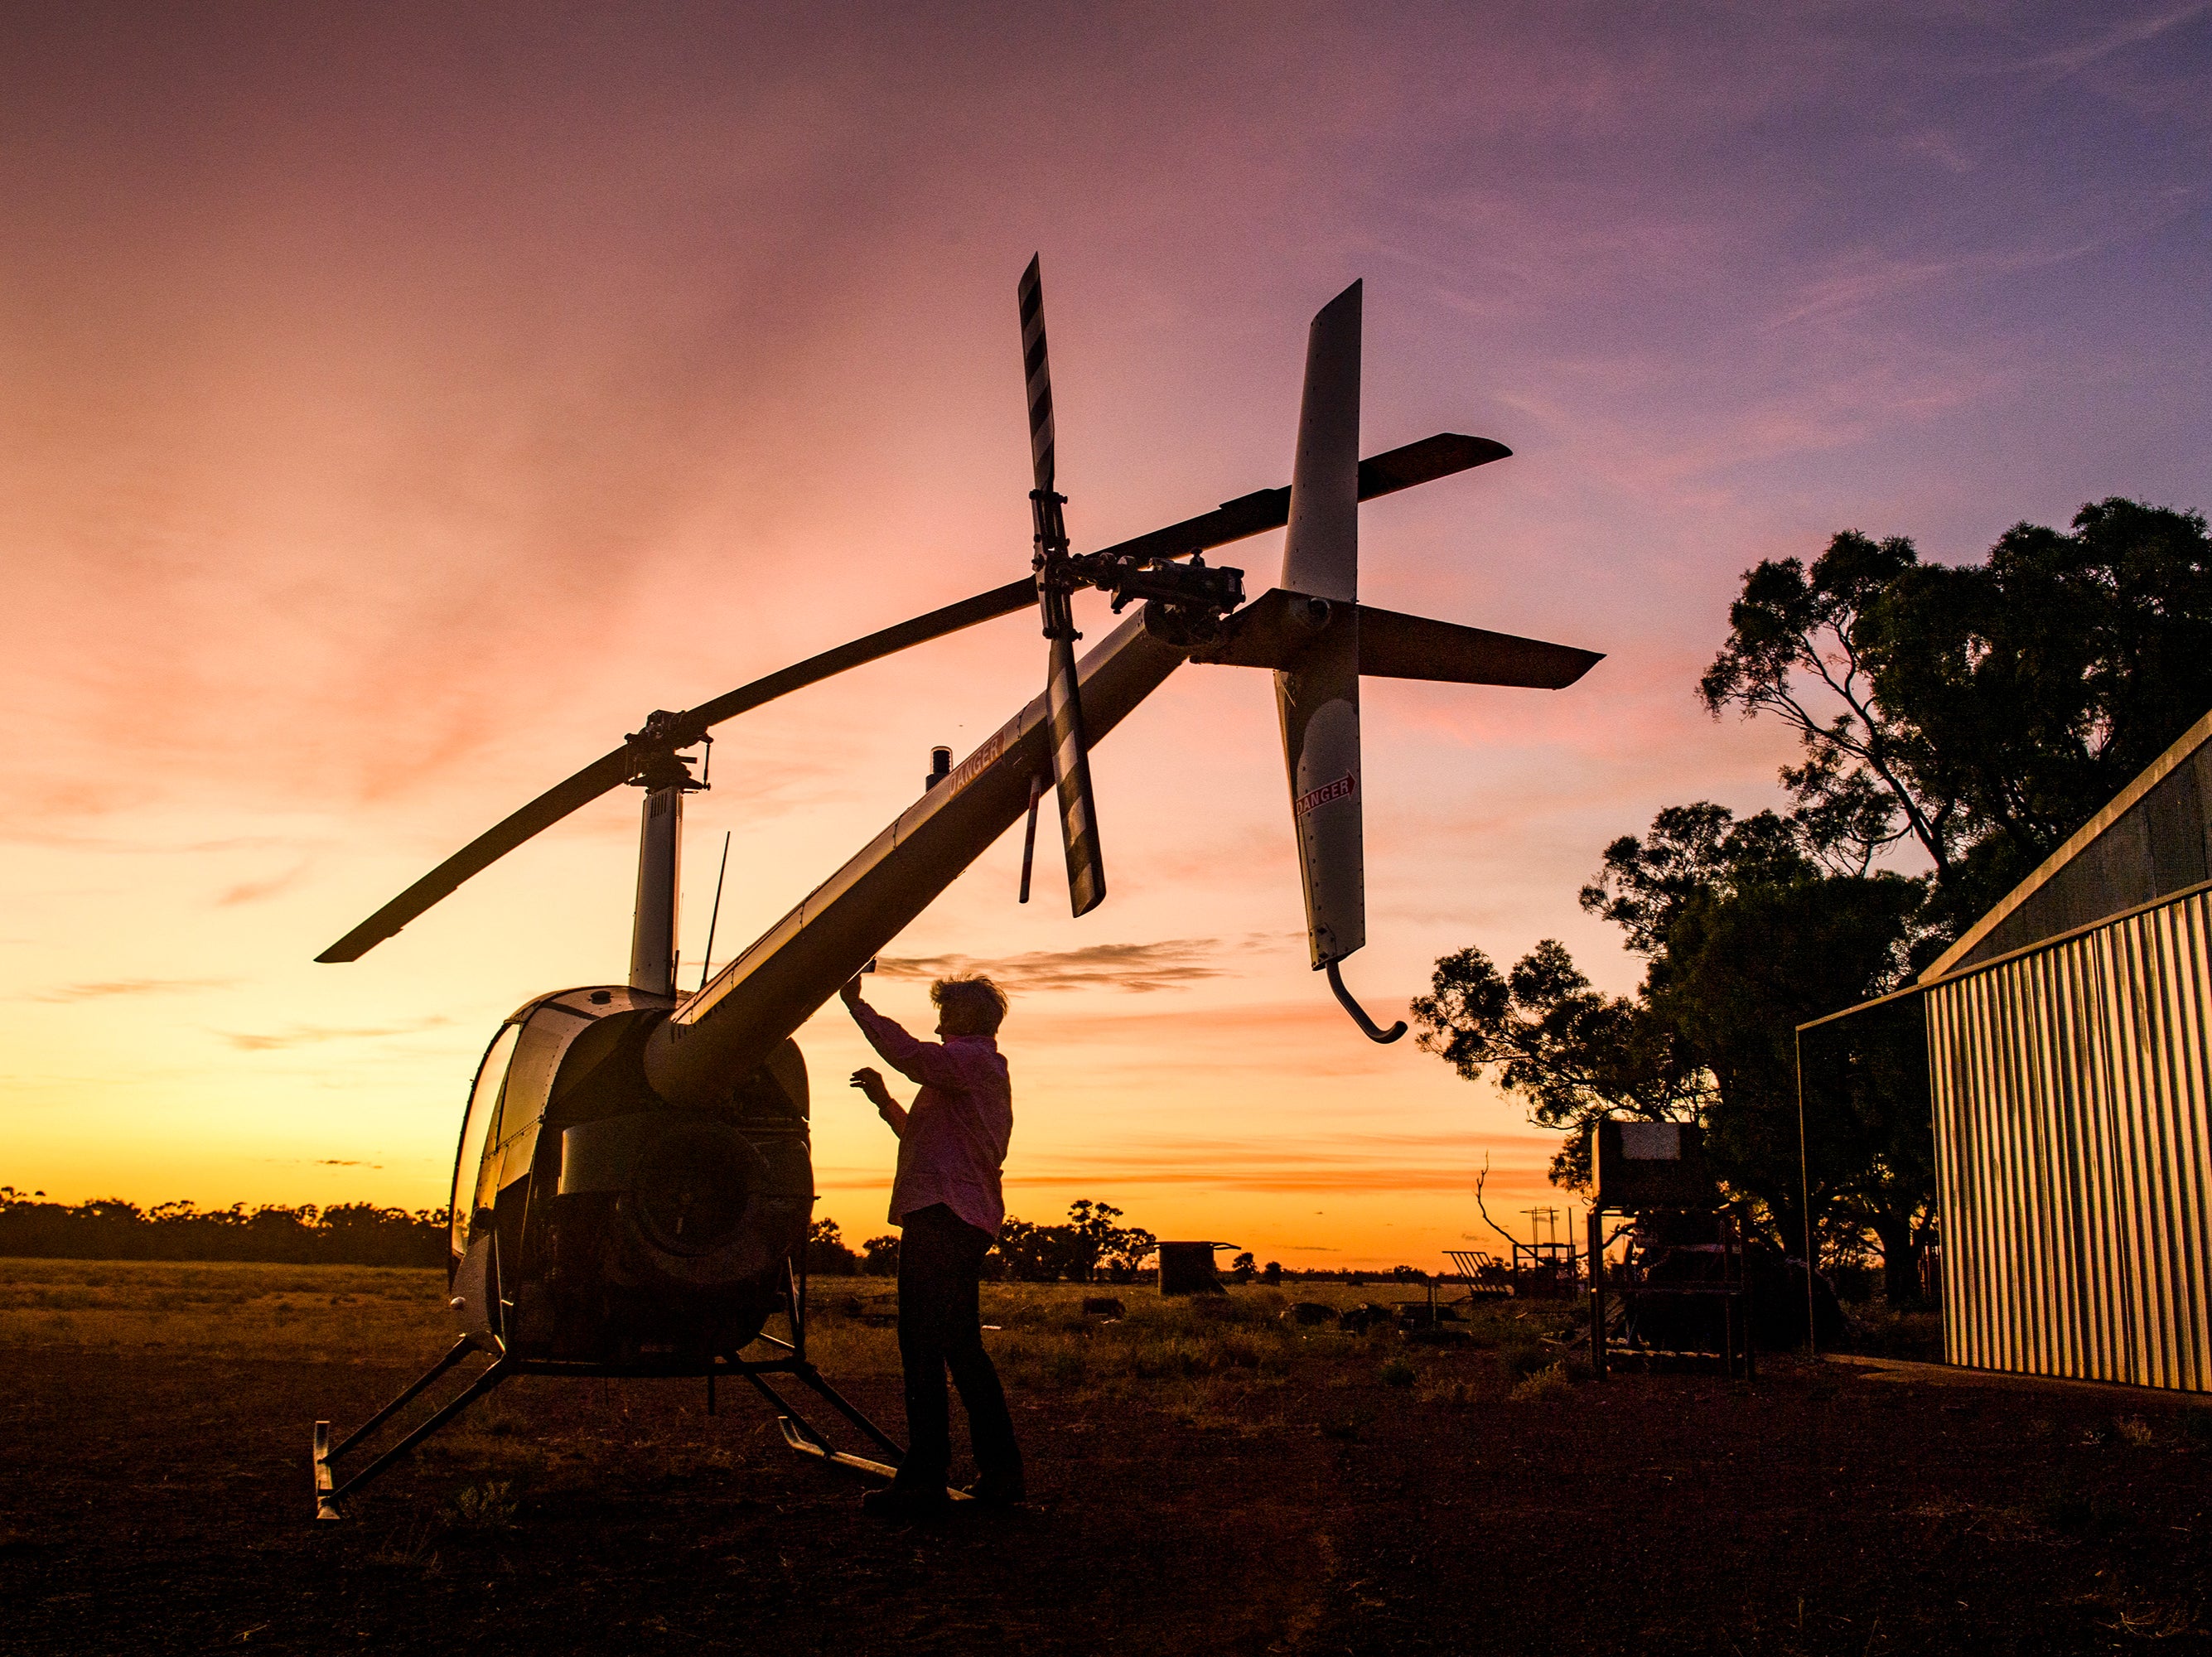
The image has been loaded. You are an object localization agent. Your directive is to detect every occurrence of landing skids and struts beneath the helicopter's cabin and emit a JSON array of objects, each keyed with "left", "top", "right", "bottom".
[{"left": 312, "top": 1272, "right": 933, "bottom": 1519}]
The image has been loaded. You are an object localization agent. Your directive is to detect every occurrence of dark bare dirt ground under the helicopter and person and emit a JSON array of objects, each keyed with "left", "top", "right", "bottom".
[{"left": 0, "top": 1261, "right": 2212, "bottom": 1657}]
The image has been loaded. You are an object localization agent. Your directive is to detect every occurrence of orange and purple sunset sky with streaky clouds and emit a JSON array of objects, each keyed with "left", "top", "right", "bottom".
[{"left": 0, "top": 4, "right": 2212, "bottom": 1265}]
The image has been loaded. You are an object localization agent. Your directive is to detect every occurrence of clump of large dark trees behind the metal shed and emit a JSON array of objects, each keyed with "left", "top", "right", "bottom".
[{"left": 1413, "top": 498, "right": 2212, "bottom": 1301}]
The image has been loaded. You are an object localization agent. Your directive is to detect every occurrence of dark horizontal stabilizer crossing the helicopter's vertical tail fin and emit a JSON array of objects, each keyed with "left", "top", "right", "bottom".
[{"left": 1192, "top": 587, "right": 1604, "bottom": 690}]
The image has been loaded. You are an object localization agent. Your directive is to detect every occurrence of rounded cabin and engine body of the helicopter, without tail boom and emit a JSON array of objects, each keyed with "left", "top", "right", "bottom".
[{"left": 453, "top": 987, "right": 814, "bottom": 1372}]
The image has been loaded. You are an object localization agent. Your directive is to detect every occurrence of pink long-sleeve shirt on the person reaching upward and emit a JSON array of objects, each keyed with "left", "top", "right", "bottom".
[{"left": 852, "top": 1002, "right": 1013, "bottom": 1237}]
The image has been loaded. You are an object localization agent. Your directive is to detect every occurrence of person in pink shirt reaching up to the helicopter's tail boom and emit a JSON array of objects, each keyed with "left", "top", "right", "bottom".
[{"left": 841, "top": 978, "right": 1024, "bottom": 1518}]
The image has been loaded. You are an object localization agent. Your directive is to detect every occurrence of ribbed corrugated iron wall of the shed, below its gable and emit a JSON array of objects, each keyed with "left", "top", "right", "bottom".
[{"left": 1927, "top": 891, "right": 2212, "bottom": 1392}]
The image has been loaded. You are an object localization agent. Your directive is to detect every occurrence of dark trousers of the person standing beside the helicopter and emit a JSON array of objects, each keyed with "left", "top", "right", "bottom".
[{"left": 898, "top": 1204, "right": 1022, "bottom": 1489}]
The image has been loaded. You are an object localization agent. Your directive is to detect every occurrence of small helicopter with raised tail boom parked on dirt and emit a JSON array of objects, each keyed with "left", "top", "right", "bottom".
[{"left": 314, "top": 258, "right": 1601, "bottom": 1518}]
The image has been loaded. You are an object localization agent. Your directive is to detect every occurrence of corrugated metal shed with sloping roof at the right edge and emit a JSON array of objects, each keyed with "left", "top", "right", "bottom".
[{"left": 1796, "top": 713, "right": 2212, "bottom": 1394}]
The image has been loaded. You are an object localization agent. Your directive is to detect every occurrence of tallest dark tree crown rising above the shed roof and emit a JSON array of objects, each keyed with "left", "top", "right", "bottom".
[{"left": 1699, "top": 498, "right": 2212, "bottom": 938}]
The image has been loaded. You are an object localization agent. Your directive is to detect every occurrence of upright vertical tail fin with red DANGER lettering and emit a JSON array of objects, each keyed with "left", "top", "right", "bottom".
[{"left": 1274, "top": 283, "right": 1367, "bottom": 971}]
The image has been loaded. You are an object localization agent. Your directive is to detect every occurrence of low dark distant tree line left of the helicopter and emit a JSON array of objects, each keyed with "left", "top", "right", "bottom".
[{"left": 0, "top": 1186, "right": 447, "bottom": 1265}]
